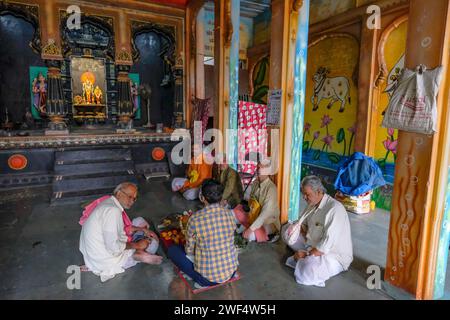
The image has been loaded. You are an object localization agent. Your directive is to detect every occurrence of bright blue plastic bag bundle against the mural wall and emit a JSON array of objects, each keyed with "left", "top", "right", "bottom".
[{"left": 334, "top": 152, "right": 386, "bottom": 196}]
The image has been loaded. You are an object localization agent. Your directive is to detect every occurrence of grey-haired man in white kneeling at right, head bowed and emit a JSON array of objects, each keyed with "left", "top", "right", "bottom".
[{"left": 282, "top": 176, "right": 353, "bottom": 287}]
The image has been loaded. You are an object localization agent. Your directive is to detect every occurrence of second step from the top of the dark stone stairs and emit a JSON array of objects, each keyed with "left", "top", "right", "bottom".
[{"left": 54, "top": 160, "right": 135, "bottom": 179}]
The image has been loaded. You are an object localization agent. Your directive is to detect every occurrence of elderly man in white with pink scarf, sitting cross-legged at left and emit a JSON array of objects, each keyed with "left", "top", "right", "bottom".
[{"left": 80, "top": 182, "right": 162, "bottom": 282}]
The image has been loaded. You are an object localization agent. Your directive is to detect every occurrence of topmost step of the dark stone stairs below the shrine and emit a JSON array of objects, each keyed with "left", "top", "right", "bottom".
[{"left": 55, "top": 148, "right": 132, "bottom": 165}]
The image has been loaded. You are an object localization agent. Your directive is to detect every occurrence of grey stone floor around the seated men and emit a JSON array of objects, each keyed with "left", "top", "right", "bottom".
[{"left": 0, "top": 180, "right": 428, "bottom": 299}]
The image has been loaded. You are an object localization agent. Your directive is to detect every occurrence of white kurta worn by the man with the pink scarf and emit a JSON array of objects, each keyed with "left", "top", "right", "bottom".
[{"left": 80, "top": 197, "right": 137, "bottom": 282}]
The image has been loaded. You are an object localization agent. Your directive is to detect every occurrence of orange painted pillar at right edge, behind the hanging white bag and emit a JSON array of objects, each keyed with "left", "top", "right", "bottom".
[{"left": 385, "top": 0, "right": 450, "bottom": 299}]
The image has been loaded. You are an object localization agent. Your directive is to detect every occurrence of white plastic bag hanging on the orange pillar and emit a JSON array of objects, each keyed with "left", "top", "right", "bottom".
[{"left": 382, "top": 65, "right": 443, "bottom": 134}]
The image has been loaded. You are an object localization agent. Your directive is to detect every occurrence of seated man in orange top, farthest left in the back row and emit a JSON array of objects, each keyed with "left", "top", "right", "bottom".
[{"left": 172, "top": 144, "right": 212, "bottom": 200}]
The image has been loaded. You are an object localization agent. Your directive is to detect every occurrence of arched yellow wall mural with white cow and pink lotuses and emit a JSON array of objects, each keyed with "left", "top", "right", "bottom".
[{"left": 302, "top": 35, "right": 359, "bottom": 193}]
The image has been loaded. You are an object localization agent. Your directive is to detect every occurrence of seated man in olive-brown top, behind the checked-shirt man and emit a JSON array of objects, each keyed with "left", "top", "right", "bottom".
[{"left": 215, "top": 154, "right": 244, "bottom": 209}]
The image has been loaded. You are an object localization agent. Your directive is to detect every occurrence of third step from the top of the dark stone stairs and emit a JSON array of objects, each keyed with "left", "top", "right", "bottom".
[{"left": 53, "top": 173, "right": 137, "bottom": 193}]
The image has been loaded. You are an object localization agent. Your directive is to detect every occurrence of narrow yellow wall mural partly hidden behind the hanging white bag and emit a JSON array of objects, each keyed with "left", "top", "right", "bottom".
[{"left": 372, "top": 21, "right": 408, "bottom": 210}]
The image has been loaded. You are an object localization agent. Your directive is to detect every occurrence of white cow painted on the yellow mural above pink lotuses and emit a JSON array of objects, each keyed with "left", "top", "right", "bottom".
[{"left": 311, "top": 67, "right": 351, "bottom": 112}]
